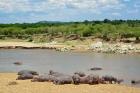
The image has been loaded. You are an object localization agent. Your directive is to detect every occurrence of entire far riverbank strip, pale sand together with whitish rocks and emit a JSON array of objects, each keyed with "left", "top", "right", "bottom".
[{"left": 0, "top": 41, "right": 140, "bottom": 54}]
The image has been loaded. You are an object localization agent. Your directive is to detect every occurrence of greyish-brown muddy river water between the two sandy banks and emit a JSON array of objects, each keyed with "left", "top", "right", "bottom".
[{"left": 0, "top": 49, "right": 140, "bottom": 87}]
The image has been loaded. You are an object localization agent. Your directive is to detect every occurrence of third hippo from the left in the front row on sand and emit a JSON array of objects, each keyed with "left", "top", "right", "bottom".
[{"left": 53, "top": 75, "right": 73, "bottom": 85}]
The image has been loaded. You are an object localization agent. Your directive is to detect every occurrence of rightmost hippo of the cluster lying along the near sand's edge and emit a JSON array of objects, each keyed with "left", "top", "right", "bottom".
[{"left": 102, "top": 76, "right": 123, "bottom": 84}]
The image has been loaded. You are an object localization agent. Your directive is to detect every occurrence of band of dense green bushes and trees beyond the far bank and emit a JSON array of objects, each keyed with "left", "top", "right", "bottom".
[{"left": 0, "top": 19, "right": 140, "bottom": 41}]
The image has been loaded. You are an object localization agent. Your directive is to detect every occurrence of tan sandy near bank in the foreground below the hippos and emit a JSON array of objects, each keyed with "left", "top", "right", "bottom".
[{"left": 0, "top": 73, "right": 140, "bottom": 93}]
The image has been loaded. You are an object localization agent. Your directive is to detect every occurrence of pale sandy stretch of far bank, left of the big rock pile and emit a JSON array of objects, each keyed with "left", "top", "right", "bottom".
[{"left": 0, "top": 41, "right": 89, "bottom": 52}]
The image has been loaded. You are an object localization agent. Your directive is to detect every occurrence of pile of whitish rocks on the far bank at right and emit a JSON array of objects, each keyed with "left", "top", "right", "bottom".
[{"left": 90, "top": 42, "right": 138, "bottom": 54}]
